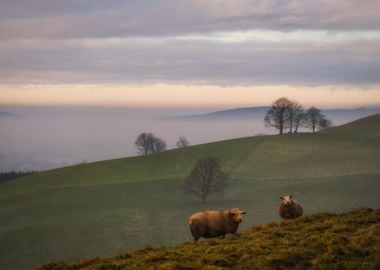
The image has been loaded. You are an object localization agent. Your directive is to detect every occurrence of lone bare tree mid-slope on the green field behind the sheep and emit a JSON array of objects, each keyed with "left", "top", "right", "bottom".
[{"left": 184, "top": 158, "right": 228, "bottom": 202}]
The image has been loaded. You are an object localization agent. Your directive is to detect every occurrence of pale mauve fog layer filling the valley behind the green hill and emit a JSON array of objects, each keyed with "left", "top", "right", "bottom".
[{"left": 0, "top": 107, "right": 378, "bottom": 171}]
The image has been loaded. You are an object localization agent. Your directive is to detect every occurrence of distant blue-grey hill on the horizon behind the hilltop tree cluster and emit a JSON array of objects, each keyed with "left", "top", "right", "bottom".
[{"left": 165, "top": 106, "right": 380, "bottom": 125}]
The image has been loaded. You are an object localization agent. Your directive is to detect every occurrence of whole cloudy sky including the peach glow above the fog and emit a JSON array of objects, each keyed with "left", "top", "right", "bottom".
[{"left": 0, "top": 0, "right": 380, "bottom": 106}]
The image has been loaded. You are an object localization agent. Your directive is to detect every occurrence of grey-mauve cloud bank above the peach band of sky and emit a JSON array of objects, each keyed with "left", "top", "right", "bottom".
[{"left": 0, "top": 0, "right": 380, "bottom": 85}]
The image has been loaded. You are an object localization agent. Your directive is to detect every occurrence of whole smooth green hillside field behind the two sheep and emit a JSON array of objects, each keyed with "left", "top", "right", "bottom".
[{"left": 0, "top": 115, "right": 380, "bottom": 269}]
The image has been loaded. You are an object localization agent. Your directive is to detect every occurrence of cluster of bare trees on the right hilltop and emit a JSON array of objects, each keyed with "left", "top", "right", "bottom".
[{"left": 264, "top": 97, "right": 331, "bottom": 134}]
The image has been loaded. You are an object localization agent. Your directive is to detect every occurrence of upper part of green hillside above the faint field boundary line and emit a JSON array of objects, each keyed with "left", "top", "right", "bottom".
[{"left": 3, "top": 115, "right": 380, "bottom": 192}]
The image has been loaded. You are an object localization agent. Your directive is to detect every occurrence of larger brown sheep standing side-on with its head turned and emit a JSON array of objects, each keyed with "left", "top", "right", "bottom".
[{"left": 189, "top": 208, "right": 246, "bottom": 242}]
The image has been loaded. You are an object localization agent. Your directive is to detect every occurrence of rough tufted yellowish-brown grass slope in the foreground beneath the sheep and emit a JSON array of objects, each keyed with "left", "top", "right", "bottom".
[{"left": 40, "top": 209, "right": 380, "bottom": 270}]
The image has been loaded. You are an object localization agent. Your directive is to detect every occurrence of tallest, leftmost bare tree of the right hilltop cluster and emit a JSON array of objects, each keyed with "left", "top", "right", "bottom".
[{"left": 264, "top": 97, "right": 292, "bottom": 134}]
